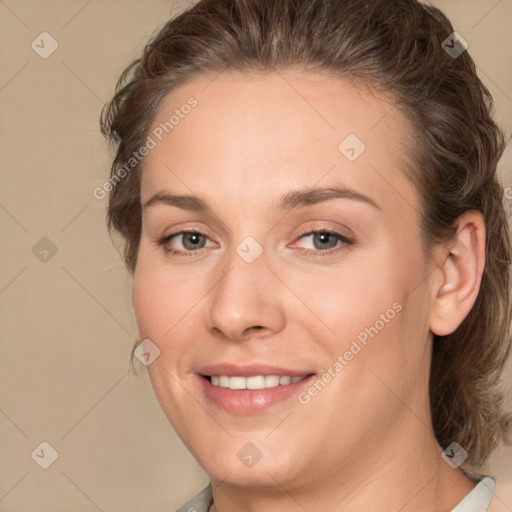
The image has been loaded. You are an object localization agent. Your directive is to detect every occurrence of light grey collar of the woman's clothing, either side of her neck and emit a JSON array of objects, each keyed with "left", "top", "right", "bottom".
[{"left": 176, "top": 468, "right": 496, "bottom": 512}]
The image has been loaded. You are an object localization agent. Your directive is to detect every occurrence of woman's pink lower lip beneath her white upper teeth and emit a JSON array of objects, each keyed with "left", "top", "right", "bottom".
[{"left": 197, "top": 375, "right": 315, "bottom": 415}]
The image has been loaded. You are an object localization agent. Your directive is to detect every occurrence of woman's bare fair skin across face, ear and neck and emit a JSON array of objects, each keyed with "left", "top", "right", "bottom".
[{"left": 133, "top": 69, "right": 485, "bottom": 512}]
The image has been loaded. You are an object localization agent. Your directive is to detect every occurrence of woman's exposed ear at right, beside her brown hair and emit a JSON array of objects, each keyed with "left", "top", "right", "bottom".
[{"left": 430, "top": 210, "right": 485, "bottom": 336}]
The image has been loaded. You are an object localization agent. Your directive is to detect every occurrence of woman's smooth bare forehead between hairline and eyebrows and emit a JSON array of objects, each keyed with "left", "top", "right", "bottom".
[{"left": 141, "top": 70, "right": 414, "bottom": 218}]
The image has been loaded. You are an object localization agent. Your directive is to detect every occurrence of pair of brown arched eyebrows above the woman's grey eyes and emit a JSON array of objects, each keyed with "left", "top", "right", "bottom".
[{"left": 142, "top": 187, "right": 382, "bottom": 214}]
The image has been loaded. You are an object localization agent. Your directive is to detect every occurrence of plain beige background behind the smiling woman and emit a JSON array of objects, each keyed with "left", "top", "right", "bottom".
[{"left": 0, "top": 0, "right": 512, "bottom": 512}]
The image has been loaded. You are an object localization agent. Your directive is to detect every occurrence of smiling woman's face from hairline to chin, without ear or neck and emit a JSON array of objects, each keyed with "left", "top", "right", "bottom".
[{"left": 133, "top": 70, "right": 436, "bottom": 489}]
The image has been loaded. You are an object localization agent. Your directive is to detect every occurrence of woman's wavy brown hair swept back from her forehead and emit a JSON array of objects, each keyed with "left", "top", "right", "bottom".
[{"left": 101, "top": 0, "right": 511, "bottom": 465}]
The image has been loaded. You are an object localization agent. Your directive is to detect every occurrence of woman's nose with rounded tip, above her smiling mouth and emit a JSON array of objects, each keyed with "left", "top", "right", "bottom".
[{"left": 207, "top": 251, "right": 285, "bottom": 341}]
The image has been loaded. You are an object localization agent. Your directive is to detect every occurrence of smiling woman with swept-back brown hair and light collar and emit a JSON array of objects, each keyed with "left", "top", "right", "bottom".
[{"left": 102, "top": 0, "right": 511, "bottom": 512}]
